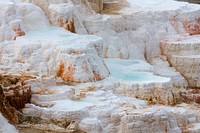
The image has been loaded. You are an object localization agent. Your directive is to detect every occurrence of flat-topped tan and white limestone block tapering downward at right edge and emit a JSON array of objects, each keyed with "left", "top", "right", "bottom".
[{"left": 161, "top": 35, "right": 200, "bottom": 88}]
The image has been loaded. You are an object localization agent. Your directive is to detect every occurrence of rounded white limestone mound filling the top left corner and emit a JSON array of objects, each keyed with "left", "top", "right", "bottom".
[{"left": 0, "top": 0, "right": 49, "bottom": 42}]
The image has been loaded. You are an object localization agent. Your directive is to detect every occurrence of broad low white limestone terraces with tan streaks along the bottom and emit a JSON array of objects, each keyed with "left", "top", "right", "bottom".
[{"left": 19, "top": 75, "right": 200, "bottom": 133}]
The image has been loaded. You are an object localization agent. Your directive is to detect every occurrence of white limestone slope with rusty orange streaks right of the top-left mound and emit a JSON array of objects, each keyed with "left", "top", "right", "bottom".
[{"left": 20, "top": 0, "right": 94, "bottom": 34}]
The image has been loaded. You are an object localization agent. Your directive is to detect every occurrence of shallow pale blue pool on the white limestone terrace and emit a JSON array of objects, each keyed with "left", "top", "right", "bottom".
[{"left": 105, "top": 59, "right": 169, "bottom": 83}]
